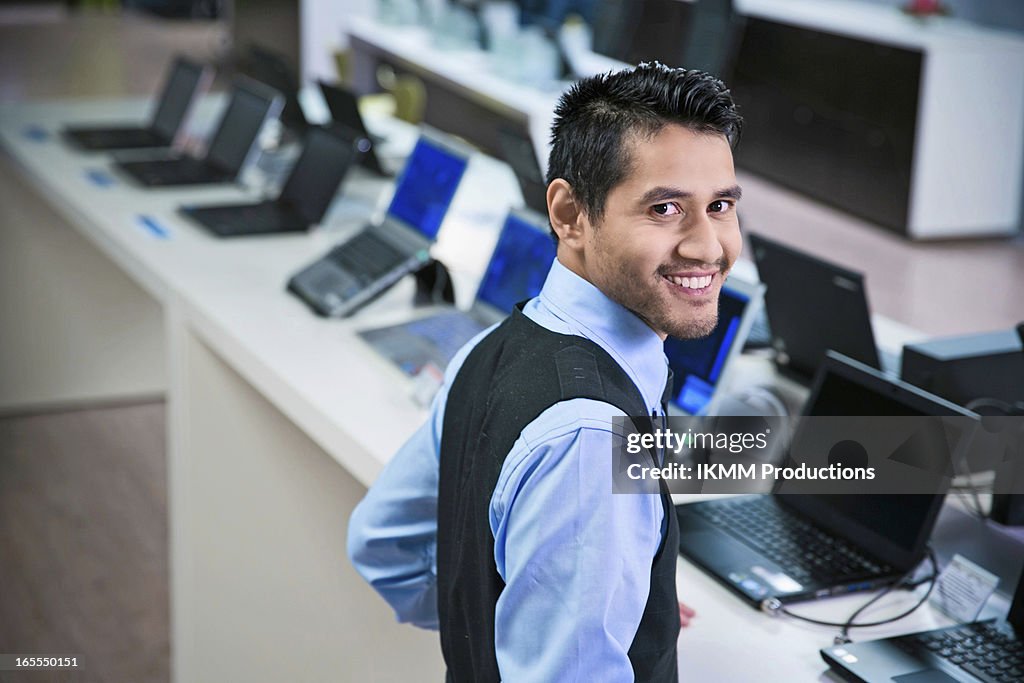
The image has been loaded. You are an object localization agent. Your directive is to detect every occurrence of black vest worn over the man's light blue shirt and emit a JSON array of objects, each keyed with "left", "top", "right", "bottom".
[{"left": 437, "top": 309, "right": 679, "bottom": 683}]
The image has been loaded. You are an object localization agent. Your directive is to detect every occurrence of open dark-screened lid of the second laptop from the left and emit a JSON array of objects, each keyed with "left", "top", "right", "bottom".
[{"left": 206, "top": 78, "right": 283, "bottom": 177}]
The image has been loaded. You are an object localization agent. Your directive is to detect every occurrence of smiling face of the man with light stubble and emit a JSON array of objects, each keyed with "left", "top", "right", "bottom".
[{"left": 582, "top": 124, "right": 742, "bottom": 339}]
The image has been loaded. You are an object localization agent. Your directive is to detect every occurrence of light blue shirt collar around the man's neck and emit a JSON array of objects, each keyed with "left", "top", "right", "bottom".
[{"left": 538, "top": 259, "right": 669, "bottom": 414}]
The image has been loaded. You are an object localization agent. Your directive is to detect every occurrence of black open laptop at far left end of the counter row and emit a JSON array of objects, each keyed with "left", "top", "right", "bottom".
[{"left": 63, "top": 57, "right": 213, "bottom": 152}]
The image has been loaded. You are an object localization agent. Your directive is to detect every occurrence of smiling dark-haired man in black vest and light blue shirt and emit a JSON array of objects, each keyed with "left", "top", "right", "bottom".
[{"left": 348, "top": 63, "right": 741, "bottom": 683}]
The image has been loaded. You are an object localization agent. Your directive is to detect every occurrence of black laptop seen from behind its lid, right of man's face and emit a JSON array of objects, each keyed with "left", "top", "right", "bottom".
[{"left": 749, "top": 232, "right": 898, "bottom": 382}]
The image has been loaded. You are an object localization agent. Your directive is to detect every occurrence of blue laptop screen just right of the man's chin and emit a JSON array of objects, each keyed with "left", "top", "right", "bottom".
[{"left": 665, "top": 286, "right": 749, "bottom": 415}]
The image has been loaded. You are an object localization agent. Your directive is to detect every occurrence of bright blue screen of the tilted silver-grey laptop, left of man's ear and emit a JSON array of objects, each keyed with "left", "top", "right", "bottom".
[{"left": 387, "top": 137, "right": 466, "bottom": 240}]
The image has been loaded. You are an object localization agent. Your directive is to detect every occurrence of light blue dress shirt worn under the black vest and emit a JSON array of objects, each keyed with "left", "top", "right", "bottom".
[{"left": 348, "top": 260, "right": 668, "bottom": 683}]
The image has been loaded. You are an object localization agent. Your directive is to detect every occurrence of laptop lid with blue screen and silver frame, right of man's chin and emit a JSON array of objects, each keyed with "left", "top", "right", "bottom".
[{"left": 665, "top": 275, "right": 765, "bottom": 415}]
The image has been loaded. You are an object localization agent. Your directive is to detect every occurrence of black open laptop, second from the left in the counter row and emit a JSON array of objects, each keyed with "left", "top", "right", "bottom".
[{"left": 117, "top": 79, "right": 281, "bottom": 187}]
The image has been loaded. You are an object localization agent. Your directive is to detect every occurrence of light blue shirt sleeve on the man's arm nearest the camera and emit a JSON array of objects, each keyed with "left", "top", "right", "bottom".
[{"left": 490, "top": 399, "right": 665, "bottom": 683}]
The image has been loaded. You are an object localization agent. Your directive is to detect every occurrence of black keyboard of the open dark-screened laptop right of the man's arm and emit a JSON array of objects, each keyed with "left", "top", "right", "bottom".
[{"left": 693, "top": 496, "right": 892, "bottom": 583}]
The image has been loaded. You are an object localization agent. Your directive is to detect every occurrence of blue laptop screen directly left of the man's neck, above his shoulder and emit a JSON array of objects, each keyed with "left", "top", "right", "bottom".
[{"left": 476, "top": 214, "right": 555, "bottom": 313}]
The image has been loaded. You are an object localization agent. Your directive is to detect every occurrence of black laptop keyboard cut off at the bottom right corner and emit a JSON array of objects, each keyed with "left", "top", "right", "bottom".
[{"left": 892, "top": 622, "right": 1024, "bottom": 683}]
